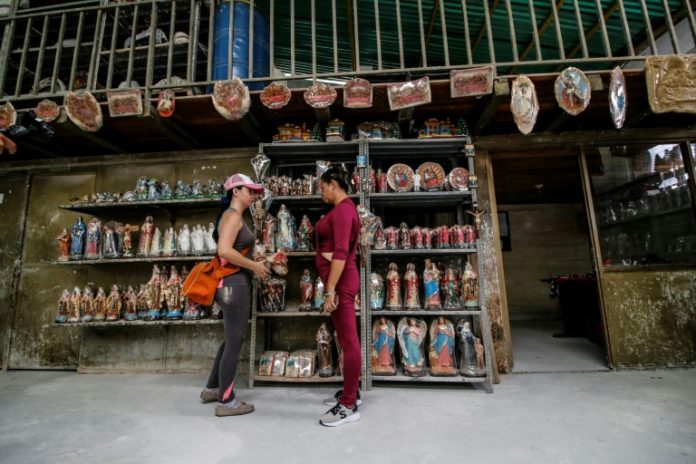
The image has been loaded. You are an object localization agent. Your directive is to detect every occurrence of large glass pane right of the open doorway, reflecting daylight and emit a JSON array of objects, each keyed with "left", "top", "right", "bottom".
[{"left": 591, "top": 143, "right": 696, "bottom": 267}]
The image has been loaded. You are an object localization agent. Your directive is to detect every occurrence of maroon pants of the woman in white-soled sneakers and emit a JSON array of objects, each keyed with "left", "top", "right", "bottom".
[{"left": 317, "top": 259, "right": 362, "bottom": 407}]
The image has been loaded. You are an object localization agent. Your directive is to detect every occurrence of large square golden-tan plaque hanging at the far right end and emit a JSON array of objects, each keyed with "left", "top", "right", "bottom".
[{"left": 645, "top": 55, "right": 696, "bottom": 114}]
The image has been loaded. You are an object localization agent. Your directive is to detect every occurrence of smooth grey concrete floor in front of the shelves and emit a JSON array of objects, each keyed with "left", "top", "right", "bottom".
[{"left": 0, "top": 369, "right": 696, "bottom": 464}]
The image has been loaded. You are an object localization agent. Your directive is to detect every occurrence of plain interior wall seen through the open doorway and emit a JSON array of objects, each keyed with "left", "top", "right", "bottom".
[{"left": 498, "top": 204, "right": 593, "bottom": 319}]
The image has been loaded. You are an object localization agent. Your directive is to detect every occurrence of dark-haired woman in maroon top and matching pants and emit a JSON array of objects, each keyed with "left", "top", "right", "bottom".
[{"left": 315, "top": 166, "right": 362, "bottom": 427}]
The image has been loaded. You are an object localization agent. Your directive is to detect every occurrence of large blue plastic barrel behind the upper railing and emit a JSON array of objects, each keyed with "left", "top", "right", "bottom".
[{"left": 213, "top": 1, "right": 270, "bottom": 90}]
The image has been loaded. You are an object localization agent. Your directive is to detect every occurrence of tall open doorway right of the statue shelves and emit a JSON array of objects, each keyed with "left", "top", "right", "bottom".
[{"left": 491, "top": 148, "right": 608, "bottom": 373}]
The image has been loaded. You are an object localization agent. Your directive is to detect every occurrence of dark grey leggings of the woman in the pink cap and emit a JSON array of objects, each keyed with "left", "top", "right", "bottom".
[{"left": 206, "top": 285, "right": 251, "bottom": 403}]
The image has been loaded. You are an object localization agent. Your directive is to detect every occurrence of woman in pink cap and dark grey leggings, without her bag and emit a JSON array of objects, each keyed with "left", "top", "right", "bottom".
[{"left": 201, "top": 174, "right": 269, "bottom": 416}]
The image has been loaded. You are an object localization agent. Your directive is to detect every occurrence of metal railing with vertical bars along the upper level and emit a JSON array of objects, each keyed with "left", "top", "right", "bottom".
[{"left": 0, "top": 0, "right": 696, "bottom": 101}]
